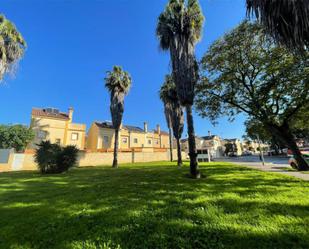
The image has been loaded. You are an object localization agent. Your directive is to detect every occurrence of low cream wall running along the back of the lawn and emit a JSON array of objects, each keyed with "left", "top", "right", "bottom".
[{"left": 0, "top": 148, "right": 186, "bottom": 172}]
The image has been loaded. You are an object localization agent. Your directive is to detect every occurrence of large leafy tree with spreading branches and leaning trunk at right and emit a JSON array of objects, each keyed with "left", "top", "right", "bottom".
[{"left": 196, "top": 22, "right": 309, "bottom": 170}]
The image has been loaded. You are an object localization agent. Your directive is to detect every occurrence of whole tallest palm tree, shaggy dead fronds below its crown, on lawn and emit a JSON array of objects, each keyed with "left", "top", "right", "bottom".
[{"left": 156, "top": 0, "right": 204, "bottom": 178}]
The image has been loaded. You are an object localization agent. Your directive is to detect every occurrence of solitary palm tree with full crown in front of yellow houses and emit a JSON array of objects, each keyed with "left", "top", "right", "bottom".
[{"left": 105, "top": 66, "right": 132, "bottom": 168}]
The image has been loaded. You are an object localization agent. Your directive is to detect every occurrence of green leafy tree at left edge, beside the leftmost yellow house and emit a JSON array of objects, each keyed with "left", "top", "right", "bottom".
[{"left": 0, "top": 125, "right": 34, "bottom": 152}]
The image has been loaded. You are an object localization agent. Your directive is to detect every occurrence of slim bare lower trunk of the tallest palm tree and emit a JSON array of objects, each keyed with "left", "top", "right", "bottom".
[{"left": 186, "top": 105, "right": 201, "bottom": 178}]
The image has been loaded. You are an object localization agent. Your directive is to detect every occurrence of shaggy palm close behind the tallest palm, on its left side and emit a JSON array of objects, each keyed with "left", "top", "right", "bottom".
[{"left": 160, "top": 75, "right": 184, "bottom": 167}]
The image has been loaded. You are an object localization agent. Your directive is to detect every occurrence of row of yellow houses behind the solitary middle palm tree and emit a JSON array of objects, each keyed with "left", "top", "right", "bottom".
[{"left": 87, "top": 121, "right": 169, "bottom": 151}]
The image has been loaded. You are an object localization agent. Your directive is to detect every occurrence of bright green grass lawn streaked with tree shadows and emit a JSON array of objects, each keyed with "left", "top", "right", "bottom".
[{"left": 0, "top": 163, "right": 309, "bottom": 249}]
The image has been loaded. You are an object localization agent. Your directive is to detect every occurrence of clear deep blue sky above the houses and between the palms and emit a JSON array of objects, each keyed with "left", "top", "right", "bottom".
[{"left": 0, "top": 0, "right": 245, "bottom": 138}]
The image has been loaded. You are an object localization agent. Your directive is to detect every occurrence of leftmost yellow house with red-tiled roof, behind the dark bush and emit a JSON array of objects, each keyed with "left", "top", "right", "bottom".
[{"left": 29, "top": 108, "right": 86, "bottom": 150}]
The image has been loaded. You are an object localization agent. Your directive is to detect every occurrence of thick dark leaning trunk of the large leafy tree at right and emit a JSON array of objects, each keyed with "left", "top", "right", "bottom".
[{"left": 271, "top": 125, "right": 309, "bottom": 171}]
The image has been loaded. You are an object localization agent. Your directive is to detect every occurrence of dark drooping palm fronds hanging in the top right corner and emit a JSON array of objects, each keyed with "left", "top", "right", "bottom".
[{"left": 247, "top": 0, "right": 309, "bottom": 50}]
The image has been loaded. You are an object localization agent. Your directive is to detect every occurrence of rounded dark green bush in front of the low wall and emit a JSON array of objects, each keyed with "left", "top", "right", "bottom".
[{"left": 35, "top": 141, "right": 78, "bottom": 174}]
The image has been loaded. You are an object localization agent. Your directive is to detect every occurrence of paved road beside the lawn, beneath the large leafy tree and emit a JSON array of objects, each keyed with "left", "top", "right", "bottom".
[{"left": 216, "top": 156, "right": 309, "bottom": 181}]
